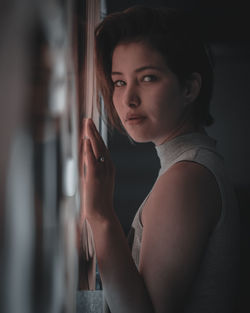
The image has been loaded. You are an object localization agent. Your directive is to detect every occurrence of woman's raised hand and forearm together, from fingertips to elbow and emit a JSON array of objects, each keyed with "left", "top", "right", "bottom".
[{"left": 80, "top": 120, "right": 154, "bottom": 313}]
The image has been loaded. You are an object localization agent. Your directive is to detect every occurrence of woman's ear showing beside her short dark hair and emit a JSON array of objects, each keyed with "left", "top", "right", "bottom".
[{"left": 184, "top": 72, "right": 202, "bottom": 105}]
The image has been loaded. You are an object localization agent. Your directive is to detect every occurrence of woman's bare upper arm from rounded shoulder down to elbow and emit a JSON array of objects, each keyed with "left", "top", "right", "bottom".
[{"left": 140, "top": 161, "right": 221, "bottom": 312}]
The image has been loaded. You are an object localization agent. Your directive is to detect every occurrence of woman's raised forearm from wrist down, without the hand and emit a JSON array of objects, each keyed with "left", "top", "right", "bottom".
[{"left": 90, "top": 214, "right": 153, "bottom": 313}]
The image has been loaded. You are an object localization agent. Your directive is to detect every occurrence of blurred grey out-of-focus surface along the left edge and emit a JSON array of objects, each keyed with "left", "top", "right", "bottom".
[{"left": 0, "top": 0, "right": 82, "bottom": 313}]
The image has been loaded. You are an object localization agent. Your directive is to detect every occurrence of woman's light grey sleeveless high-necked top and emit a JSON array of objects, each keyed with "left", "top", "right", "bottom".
[{"left": 128, "top": 133, "right": 240, "bottom": 313}]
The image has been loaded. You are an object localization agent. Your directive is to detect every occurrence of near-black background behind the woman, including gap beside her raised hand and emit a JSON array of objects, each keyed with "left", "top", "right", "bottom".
[{"left": 107, "top": 0, "right": 250, "bottom": 312}]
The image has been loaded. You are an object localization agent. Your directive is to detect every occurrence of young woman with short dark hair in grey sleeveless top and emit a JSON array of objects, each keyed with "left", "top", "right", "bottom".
[{"left": 82, "top": 7, "right": 238, "bottom": 313}]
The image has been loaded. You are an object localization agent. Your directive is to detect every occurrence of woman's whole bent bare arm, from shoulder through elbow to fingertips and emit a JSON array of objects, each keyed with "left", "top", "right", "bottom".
[{"left": 81, "top": 118, "right": 220, "bottom": 313}]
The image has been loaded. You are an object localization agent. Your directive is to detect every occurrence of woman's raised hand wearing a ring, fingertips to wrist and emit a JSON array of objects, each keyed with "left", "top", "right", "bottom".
[{"left": 81, "top": 119, "right": 115, "bottom": 224}]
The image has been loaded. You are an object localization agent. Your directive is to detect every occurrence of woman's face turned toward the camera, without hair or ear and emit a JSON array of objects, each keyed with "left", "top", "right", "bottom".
[{"left": 112, "top": 42, "right": 189, "bottom": 145}]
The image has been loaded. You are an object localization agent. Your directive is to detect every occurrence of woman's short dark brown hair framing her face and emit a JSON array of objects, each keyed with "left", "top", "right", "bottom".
[{"left": 95, "top": 6, "right": 213, "bottom": 130}]
